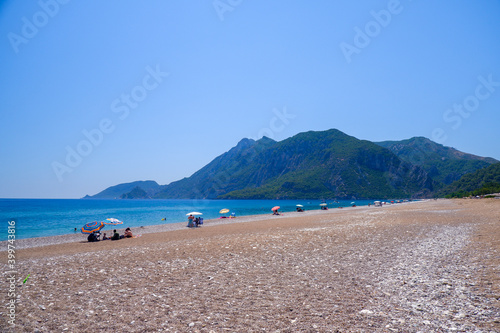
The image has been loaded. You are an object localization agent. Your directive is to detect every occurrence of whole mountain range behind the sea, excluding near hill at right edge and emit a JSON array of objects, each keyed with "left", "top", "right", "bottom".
[{"left": 86, "top": 129, "right": 496, "bottom": 199}]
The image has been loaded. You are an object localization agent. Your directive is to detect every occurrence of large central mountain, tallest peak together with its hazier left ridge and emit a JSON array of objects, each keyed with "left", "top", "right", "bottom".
[{"left": 155, "top": 130, "right": 432, "bottom": 199}]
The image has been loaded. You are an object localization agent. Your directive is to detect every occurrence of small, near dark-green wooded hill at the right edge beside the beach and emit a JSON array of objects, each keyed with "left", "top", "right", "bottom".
[{"left": 441, "top": 163, "right": 500, "bottom": 198}]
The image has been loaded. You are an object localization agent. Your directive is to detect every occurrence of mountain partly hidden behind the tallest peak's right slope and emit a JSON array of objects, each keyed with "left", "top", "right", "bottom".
[{"left": 376, "top": 137, "right": 498, "bottom": 188}]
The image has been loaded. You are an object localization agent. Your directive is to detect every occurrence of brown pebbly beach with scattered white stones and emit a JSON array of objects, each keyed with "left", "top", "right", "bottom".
[{"left": 0, "top": 199, "right": 500, "bottom": 332}]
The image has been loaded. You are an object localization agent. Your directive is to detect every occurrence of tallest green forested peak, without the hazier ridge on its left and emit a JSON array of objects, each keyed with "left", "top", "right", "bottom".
[{"left": 217, "top": 130, "right": 432, "bottom": 199}]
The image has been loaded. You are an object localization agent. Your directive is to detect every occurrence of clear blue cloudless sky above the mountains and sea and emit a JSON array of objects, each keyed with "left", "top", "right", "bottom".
[{"left": 0, "top": 0, "right": 500, "bottom": 198}]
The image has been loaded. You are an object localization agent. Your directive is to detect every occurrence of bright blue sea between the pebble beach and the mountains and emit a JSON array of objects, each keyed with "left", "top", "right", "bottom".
[{"left": 0, "top": 199, "right": 373, "bottom": 241}]
